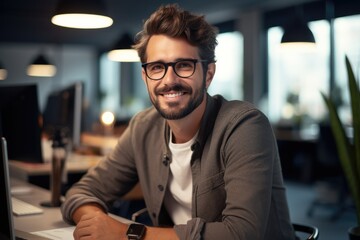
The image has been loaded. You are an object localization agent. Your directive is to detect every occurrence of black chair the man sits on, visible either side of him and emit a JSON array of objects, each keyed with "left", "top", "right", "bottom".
[{"left": 131, "top": 208, "right": 319, "bottom": 240}]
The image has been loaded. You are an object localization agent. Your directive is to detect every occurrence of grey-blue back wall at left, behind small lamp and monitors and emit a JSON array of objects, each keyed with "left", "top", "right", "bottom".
[{"left": 0, "top": 43, "right": 98, "bottom": 128}]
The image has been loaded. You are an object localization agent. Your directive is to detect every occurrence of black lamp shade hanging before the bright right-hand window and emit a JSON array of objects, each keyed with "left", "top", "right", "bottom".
[{"left": 281, "top": 18, "right": 315, "bottom": 44}]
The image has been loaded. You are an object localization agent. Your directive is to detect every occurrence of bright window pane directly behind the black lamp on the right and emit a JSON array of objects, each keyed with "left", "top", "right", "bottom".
[{"left": 267, "top": 20, "right": 330, "bottom": 125}]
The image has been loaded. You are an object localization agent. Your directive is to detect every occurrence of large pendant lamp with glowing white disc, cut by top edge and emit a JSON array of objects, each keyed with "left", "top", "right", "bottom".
[{"left": 51, "top": 0, "right": 113, "bottom": 29}]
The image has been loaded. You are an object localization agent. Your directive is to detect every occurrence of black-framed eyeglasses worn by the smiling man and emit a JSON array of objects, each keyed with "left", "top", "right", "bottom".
[{"left": 141, "top": 59, "right": 208, "bottom": 81}]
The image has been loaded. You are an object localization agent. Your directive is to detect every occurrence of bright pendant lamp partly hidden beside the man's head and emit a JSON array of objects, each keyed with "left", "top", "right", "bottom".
[{"left": 108, "top": 33, "right": 140, "bottom": 62}]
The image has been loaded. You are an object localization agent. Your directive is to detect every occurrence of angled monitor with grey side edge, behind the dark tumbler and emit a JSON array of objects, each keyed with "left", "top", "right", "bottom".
[{"left": 43, "top": 82, "right": 83, "bottom": 148}]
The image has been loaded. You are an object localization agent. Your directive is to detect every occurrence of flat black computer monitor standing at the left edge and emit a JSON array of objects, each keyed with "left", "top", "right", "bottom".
[{"left": 0, "top": 84, "right": 43, "bottom": 163}]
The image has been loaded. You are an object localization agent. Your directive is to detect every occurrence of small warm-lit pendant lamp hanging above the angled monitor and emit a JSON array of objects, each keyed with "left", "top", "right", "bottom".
[{"left": 27, "top": 54, "right": 56, "bottom": 77}]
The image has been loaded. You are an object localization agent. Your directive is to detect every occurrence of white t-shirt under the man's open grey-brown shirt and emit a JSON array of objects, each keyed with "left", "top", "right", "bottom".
[{"left": 165, "top": 132, "right": 197, "bottom": 224}]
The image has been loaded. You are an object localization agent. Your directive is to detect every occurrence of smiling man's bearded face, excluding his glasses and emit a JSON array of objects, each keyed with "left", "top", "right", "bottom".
[{"left": 142, "top": 35, "right": 213, "bottom": 120}]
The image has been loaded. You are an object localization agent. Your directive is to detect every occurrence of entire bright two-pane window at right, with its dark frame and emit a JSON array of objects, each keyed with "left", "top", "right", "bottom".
[{"left": 264, "top": 0, "right": 360, "bottom": 129}]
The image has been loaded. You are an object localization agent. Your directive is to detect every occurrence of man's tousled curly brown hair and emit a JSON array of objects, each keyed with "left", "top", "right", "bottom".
[{"left": 133, "top": 4, "right": 217, "bottom": 63}]
